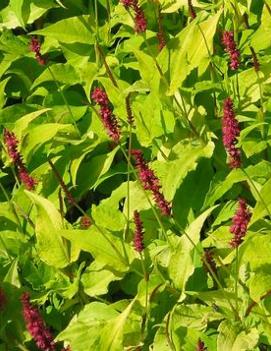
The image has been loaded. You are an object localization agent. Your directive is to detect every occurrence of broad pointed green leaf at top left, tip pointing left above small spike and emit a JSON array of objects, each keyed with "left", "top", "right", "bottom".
[{"left": 31, "top": 16, "right": 94, "bottom": 45}]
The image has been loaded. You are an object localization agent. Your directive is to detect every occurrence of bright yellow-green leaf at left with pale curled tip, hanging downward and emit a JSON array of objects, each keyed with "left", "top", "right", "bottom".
[{"left": 25, "top": 190, "right": 70, "bottom": 268}]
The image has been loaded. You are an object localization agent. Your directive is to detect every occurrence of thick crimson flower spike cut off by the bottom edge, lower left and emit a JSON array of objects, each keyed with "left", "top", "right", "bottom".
[{"left": 21, "top": 293, "right": 56, "bottom": 351}]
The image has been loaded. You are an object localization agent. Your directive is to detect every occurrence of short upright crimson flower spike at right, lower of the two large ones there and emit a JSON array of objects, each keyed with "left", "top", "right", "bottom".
[{"left": 230, "top": 199, "right": 251, "bottom": 248}]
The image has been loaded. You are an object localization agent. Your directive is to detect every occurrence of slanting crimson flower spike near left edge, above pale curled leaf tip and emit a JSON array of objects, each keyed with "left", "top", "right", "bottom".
[{"left": 4, "top": 128, "right": 37, "bottom": 190}]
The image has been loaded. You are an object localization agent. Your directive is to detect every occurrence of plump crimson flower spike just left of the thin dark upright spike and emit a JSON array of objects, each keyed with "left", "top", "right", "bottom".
[{"left": 91, "top": 88, "right": 120, "bottom": 143}]
